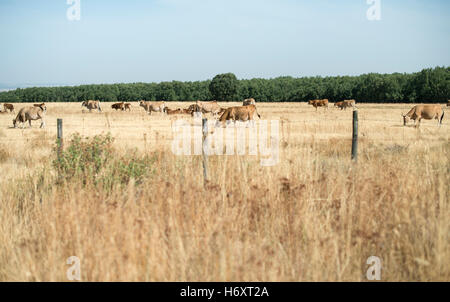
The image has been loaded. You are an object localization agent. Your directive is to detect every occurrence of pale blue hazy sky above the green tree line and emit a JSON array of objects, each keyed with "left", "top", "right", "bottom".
[{"left": 0, "top": 0, "right": 450, "bottom": 88}]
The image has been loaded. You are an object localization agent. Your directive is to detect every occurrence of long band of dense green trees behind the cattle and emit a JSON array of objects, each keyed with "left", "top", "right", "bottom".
[{"left": 0, "top": 67, "right": 450, "bottom": 103}]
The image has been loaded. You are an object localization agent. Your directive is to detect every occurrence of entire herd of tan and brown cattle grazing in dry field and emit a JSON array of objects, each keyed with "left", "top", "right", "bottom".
[{"left": 0, "top": 98, "right": 450, "bottom": 128}]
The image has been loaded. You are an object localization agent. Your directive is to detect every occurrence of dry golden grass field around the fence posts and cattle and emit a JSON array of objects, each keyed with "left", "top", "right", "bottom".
[{"left": 0, "top": 103, "right": 450, "bottom": 281}]
